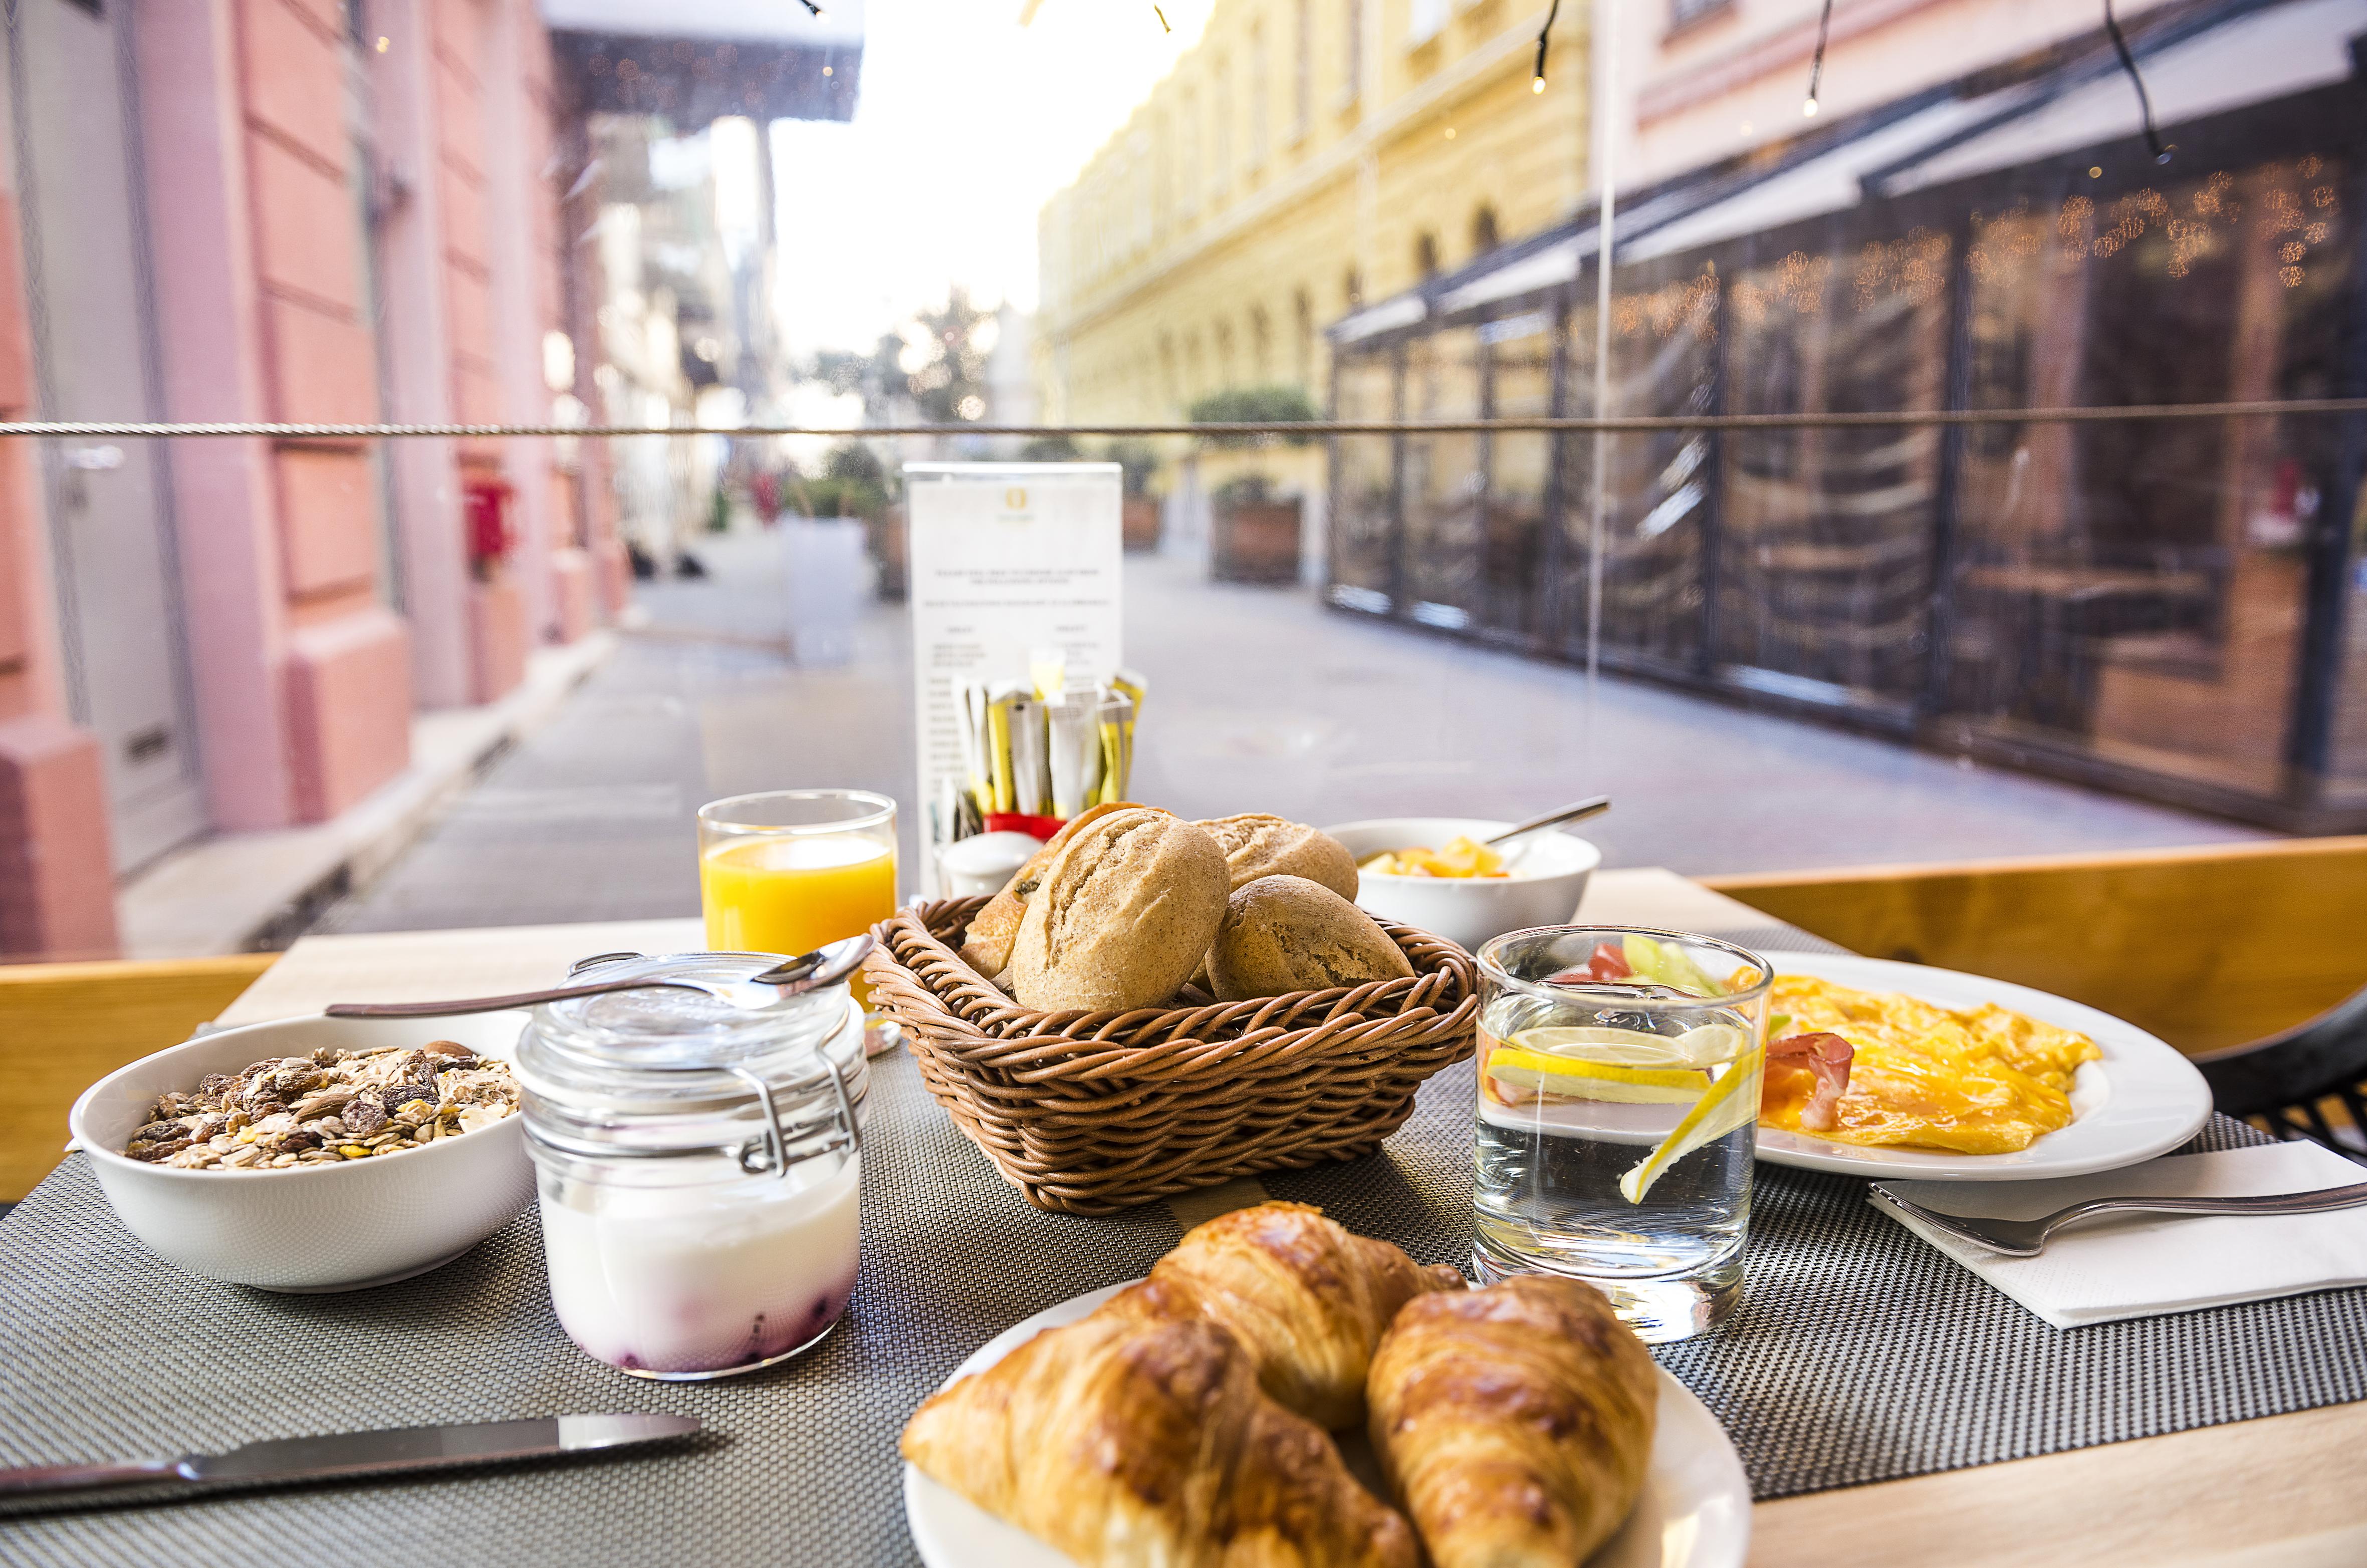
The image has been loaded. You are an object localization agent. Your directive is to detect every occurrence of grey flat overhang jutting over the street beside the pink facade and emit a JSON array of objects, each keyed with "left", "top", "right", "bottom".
[{"left": 542, "top": 0, "right": 864, "bottom": 130}]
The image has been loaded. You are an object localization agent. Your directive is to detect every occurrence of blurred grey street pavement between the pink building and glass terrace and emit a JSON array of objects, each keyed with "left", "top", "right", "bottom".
[{"left": 315, "top": 535, "right": 2265, "bottom": 932}]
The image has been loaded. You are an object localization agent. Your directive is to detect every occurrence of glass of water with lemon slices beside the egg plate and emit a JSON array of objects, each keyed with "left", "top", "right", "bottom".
[{"left": 1472, "top": 925, "right": 1771, "bottom": 1344}]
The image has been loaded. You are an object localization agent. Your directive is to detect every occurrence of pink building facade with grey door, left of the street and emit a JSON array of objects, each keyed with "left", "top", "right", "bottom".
[{"left": 0, "top": 0, "right": 625, "bottom": 958}]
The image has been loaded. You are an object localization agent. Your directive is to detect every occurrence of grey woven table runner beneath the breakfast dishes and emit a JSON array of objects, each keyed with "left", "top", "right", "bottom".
[{"left": 0, "top": 929, "right": 2367, "bottom": 1565}]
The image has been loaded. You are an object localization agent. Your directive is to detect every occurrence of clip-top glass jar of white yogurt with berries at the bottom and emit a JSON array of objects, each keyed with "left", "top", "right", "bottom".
[{"left": 516, "top": 953, "right": 869, "bottom": 1379}]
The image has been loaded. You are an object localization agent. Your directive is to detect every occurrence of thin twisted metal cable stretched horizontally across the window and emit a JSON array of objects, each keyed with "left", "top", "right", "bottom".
[{"left": 0, "top": 397, "right": 2367, "bottom": 440}]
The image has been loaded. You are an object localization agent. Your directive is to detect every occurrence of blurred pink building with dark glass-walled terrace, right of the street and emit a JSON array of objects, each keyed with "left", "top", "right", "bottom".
[{"left": 1330, "top": 0, "right": 2367, "bottom": 830}]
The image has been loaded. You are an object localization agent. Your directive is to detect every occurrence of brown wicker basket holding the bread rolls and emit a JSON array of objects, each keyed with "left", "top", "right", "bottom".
[{"left": 864, "top": 899, "right": 1480, "bottom": 1213}]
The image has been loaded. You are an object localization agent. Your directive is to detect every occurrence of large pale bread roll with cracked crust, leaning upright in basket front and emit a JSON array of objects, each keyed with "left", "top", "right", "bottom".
[{"left": 1011, "top": 807, "right": 1226, "bottom": 1010}]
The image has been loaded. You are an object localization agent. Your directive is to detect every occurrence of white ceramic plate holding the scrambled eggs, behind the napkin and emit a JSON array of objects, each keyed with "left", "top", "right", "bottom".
[{"left": 1759, "top": 953, "right": 2211, "bottom": 1182}]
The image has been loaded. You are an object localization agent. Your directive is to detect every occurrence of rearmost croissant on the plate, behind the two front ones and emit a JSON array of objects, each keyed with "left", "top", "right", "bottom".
[{"left": 1103, "top": 1204, "right": 1463, "bottom": 1431}]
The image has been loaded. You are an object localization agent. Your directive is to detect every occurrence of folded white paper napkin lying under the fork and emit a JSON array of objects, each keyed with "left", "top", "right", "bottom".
[{"left": 1865, "top": 1140, "right": 2367, "bottom": 1329}]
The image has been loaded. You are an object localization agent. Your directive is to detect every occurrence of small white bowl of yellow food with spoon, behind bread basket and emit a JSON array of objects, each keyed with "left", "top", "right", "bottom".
[{"left": 1323, "top": 816, "right": 1602, "bottom": 951}]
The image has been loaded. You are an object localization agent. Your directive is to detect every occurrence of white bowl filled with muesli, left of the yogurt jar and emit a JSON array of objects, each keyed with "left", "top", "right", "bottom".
[{"left": 66, "top": 1012, "right": 535, "bottom": 1291}]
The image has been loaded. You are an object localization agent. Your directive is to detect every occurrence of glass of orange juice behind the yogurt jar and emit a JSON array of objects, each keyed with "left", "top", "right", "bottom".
[{"left": 698, "top": 835, "right": 895, "bottom": 1005}]
